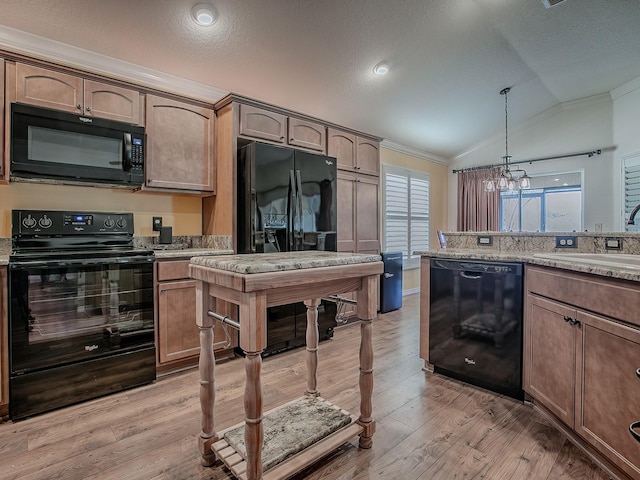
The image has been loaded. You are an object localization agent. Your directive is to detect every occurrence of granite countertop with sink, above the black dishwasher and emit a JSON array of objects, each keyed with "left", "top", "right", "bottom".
[{"left": 415, "top": 249, "right": 640, "bottom": 282}]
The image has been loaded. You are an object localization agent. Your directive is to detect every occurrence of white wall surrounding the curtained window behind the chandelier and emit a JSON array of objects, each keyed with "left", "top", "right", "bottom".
[{"left": 448, "top": 94, "right": 619, "bottom": 232}]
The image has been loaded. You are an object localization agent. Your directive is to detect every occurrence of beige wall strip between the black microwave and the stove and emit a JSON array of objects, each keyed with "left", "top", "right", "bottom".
[{"left": 0, "top": 183, "right": 202, "bottom": 238}]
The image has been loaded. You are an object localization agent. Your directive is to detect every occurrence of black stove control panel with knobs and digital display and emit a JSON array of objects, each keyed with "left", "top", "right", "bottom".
[{"left": 11, "top": 210, "right": 133, "bottom": 236}]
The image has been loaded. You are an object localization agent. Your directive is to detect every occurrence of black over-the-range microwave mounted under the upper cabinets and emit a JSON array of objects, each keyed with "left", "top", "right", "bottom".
[{"left": 10, "top": 103, "right": 145, "bottom": 188}]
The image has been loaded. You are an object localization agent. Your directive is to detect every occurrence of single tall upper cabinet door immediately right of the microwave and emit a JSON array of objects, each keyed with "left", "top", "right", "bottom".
[{"left": 145, "top": 95, "right": 215, "bottom": 192}]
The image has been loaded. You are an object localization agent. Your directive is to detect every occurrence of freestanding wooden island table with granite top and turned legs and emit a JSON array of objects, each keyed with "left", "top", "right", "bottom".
[{"left": 189, "top": 251, "right": 383, "bottom": 480}]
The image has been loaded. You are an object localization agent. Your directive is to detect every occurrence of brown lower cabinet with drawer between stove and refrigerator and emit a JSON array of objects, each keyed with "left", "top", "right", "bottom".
[{"left": 155, "top": 260, "right": 237, "bottom": 371}]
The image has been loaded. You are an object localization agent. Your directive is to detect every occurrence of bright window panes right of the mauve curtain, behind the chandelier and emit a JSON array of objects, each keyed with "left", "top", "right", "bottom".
[{"left": 500, "top": 172, "right": 583, "bottom": 232}]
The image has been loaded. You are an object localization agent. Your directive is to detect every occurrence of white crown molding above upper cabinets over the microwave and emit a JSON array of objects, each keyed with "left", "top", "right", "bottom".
[{"left": 0, "top": 25, "right": 229, "bottom": 103}]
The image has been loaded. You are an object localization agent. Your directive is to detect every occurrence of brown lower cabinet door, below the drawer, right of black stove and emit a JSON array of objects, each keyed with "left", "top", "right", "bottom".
[{"left": 158, "top": 280, "right": 200, "bottom": 363}]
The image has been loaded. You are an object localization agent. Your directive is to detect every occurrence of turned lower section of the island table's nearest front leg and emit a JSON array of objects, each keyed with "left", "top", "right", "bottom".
[{"left": 244, "top": 352, "right": 263, "bottom": 480}]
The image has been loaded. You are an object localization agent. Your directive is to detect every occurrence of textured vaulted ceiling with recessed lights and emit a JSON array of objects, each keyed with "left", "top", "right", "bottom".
[{"left": 0, "top": 0, "right": 640, "bottom": 158}]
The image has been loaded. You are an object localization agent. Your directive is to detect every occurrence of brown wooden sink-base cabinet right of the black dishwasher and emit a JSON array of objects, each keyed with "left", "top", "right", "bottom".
[{"left": 524, "top": 267, "right": 640, "bottom": 479}]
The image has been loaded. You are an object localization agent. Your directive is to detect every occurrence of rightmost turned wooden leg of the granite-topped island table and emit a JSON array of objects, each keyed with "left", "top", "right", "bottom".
[{"left": 356, "top": 276, "right": 378, "bottom": 448}]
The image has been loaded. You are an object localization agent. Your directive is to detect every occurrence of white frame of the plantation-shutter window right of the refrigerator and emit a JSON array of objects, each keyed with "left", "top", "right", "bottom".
[{"left": 381, "top": 164, "right": 431, "bottom": 270}]
